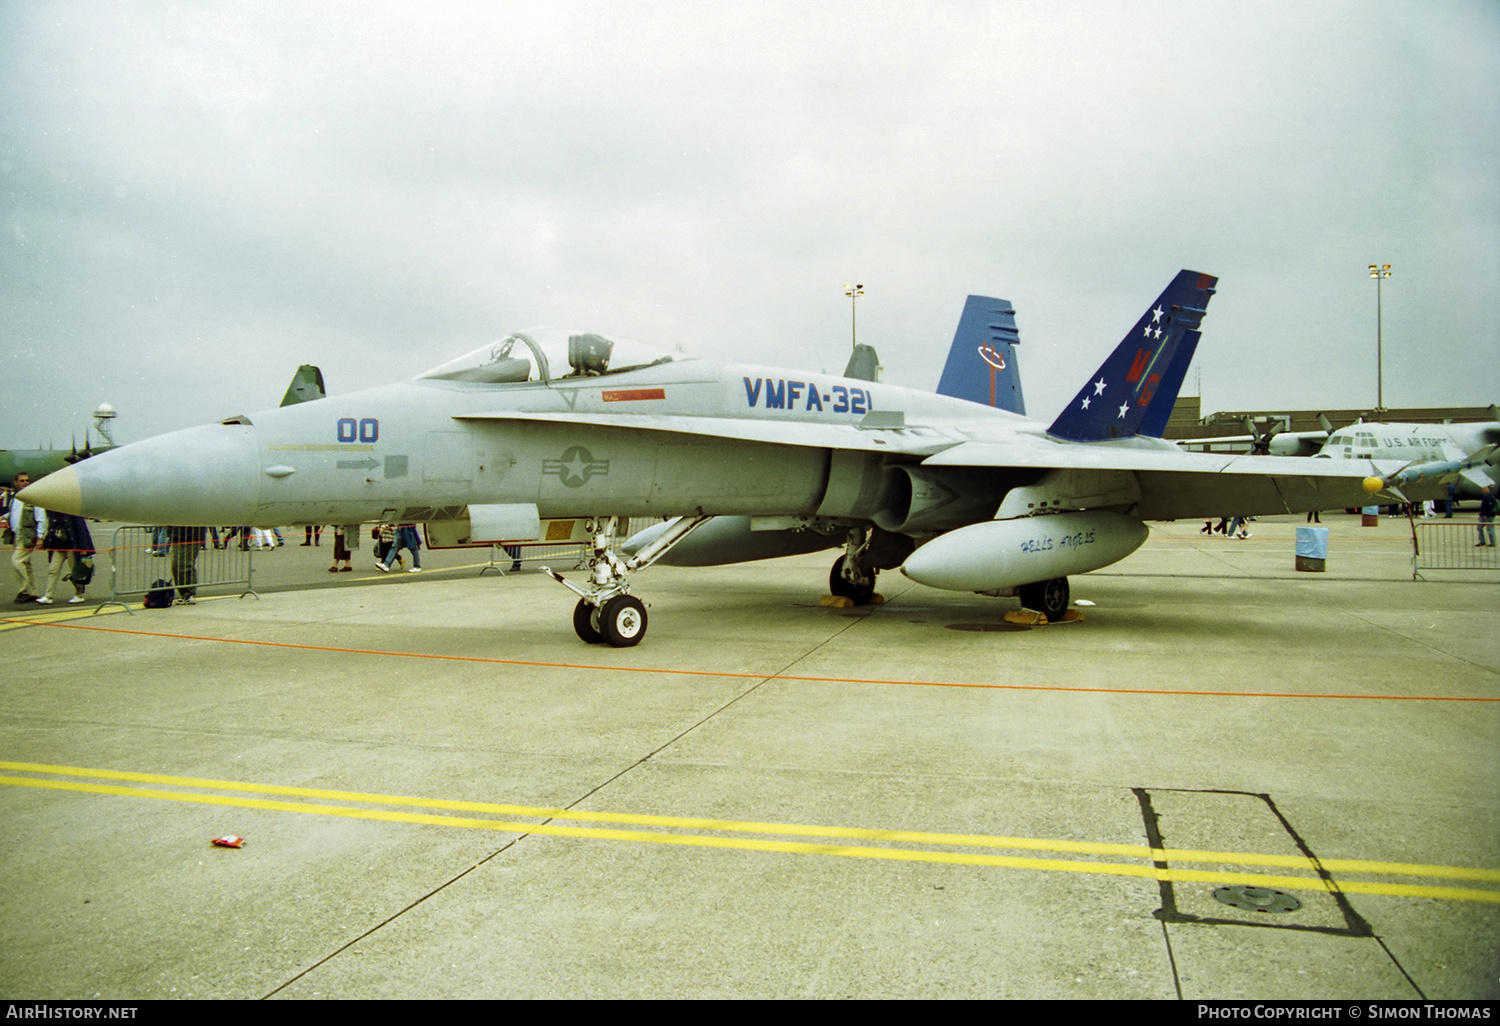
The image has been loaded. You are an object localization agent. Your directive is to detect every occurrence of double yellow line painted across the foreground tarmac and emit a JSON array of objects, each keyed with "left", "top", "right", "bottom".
[{"left": 0, "top": 762, "right": 1500, "bottom": 903}]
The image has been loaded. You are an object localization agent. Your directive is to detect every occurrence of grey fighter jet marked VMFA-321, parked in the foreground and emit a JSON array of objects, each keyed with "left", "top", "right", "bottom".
[{"left": 23, "top": 272, "right": 1446, "bottom": 647}]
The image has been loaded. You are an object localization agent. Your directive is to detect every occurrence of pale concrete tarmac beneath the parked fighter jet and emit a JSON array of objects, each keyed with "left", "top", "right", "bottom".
[{"left": 0, "top": 515, "right": 1500, "bottom": 1001}]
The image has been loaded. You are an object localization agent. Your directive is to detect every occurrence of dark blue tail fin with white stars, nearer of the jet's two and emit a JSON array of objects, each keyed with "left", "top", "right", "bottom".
[{"left": 1047, "top": 270, "right": 1218, "bottom": 441}]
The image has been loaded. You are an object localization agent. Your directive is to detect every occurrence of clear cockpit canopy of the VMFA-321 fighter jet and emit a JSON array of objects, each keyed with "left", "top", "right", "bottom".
[{"left": 422, "top": 329, "right": 680, "bottom": 384}]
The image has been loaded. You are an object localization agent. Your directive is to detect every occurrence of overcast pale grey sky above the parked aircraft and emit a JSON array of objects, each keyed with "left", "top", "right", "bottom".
[{"left": 0, "top": 0, "right": 1500, "bottom": 447}]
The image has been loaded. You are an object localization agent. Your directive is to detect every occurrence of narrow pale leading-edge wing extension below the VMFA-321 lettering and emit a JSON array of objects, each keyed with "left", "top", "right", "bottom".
[{"left": 455, "top": 410, "right": 963, "bottom": 456}]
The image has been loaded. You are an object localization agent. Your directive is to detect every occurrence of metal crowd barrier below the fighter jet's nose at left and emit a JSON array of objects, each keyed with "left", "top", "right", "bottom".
[{"left": 95, "top": 527, "right": 260, "bottom": 614}]
